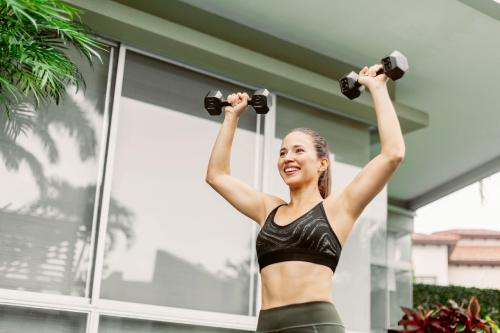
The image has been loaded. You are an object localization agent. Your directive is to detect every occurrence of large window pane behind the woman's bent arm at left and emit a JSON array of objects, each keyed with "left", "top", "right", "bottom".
[{"left": 101, "top": 52, "right": 257, "bottom": 314}]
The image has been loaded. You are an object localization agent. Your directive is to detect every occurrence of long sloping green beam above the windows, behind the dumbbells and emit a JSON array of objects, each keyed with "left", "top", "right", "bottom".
[{"left": 65, "top": 0, "right": 428, "bottom": 132}]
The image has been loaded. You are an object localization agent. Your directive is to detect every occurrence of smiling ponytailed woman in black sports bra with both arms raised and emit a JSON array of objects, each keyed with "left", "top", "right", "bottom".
[{"left": 206, "top": 64, "right": 405, "bottom": 333}]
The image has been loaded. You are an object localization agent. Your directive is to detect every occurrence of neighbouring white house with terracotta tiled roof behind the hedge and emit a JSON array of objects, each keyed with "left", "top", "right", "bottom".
[{"left": 412, "top": 229, "right": 500, "bottom": 289}]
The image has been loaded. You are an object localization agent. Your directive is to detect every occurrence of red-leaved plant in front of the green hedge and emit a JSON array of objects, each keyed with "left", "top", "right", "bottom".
[{"left": 391, "top": 296, "right": 498, "bottom": 333}]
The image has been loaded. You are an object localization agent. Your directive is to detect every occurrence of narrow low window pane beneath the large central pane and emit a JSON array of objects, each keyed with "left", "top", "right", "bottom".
[{"left": 99, "top": 317, "right": 253, "bottom": 333}]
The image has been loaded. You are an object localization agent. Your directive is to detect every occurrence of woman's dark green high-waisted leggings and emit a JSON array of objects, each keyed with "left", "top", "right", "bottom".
[{"left": 255, "top": 301, "right": 345, "bottom": 333}]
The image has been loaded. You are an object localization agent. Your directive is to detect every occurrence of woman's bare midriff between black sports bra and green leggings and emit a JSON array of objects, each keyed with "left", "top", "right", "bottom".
[{"left": 260, "top": 261, "right": 333, "bottom": 310}]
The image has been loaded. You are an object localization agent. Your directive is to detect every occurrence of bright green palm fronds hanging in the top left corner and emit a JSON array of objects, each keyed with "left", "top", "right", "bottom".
[{"left": 0, "top": 0, "right": 107, "bottom": 117}]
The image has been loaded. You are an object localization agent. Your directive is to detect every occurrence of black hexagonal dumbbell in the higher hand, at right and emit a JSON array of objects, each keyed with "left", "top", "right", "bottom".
[{"left": 339, "top": 51, "right": 408, "bottom": 99}]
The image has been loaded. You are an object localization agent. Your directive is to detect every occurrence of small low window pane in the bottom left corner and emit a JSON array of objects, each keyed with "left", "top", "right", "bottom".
[{"left": 0, "top": 306, "right": 87, "bottom": 333}]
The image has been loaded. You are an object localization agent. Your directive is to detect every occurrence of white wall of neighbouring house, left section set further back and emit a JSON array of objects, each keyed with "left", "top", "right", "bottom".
[{"left": 412, "top": 245, "right": 448, "bottom": 285}]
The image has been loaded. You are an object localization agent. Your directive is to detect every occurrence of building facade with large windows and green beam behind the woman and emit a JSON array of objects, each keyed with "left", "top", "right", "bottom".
[{"left": 0, "top": 1, "right": 413, "bottom": 333}]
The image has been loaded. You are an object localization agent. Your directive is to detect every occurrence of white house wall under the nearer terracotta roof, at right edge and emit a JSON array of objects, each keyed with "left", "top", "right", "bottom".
[{"left": 448, "top": 265, "right": 500, "bottom": 289}]
